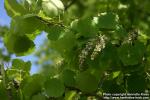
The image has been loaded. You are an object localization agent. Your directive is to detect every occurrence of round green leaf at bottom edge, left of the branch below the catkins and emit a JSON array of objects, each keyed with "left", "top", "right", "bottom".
[{"left": 44, "top": 78, "right": 65, "bottom": 97}]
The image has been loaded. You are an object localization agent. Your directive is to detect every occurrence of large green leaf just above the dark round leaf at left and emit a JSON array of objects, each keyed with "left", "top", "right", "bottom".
[{"left": 11, "top": 14, "right": 44, "bottom": 35}]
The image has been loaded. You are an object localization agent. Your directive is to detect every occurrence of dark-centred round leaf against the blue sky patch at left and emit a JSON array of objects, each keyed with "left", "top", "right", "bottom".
[{"left": 4, "top": 34, "right": 34, "bottom": 55}]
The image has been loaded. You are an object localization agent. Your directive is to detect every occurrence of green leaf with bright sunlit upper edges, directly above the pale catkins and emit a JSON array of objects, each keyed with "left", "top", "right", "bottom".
[{"left": 98, "top": 13, "right": 118, "bottom": 30}]
